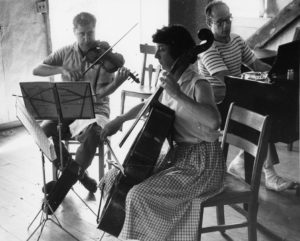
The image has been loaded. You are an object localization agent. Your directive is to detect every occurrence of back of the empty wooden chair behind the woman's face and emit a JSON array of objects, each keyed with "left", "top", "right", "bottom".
[{"left": 140, "top": 44, "right": 161, "bottom": 88}]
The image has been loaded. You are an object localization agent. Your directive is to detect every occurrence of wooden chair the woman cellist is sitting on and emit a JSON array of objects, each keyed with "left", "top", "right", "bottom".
[{"left": 199, "top": 103, "right": 269, "bottom": 241}]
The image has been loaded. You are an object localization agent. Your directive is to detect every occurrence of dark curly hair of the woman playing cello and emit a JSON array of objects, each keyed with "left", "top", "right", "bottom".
[{"left": 152, "top": 24, "right": 196, "bottom": 62}]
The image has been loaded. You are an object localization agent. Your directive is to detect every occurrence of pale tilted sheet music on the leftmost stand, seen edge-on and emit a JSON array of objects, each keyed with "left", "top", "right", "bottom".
[{"left": 16, "top": 98, "right": 56, "bottom": 161}]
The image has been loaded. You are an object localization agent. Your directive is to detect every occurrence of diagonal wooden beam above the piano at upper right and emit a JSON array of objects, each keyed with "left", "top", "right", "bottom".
[{"left": 246, "top": 0, "right": 300, "bottom": 49}]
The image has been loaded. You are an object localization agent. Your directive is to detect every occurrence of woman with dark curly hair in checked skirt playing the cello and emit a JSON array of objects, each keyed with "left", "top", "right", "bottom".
[{"left": 99, "top": 25, "right": 226, "bottom": 240}]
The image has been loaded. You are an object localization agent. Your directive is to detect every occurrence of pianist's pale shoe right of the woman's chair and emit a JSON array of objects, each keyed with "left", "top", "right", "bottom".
[{"left": 263, "top": 168, "right": 294, "bottom": 192}]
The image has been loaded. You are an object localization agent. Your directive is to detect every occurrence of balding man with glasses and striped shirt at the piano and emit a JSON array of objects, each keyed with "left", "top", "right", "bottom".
[{"left": 198, "top": 0, "right": 293, "bottom": 191}]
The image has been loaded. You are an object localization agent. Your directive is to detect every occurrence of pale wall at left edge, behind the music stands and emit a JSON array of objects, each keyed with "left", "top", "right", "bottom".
[{"left": 0, "top": 0, "right": 47, "bottom": 125}]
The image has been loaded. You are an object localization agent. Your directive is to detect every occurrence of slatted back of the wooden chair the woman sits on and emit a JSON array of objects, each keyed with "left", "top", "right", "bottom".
[{"left": 221, "top": 103, "right": 270, "bottom": 198}]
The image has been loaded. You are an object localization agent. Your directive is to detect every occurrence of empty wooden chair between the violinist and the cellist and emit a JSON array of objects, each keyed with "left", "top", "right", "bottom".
[{"left": 121, "top": 44, "right": 161, "bottom": 114}]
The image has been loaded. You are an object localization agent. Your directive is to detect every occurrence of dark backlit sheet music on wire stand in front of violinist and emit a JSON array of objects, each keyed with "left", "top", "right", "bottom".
[{"left": 20, "top": 82, "right": 95, "bottom": 120}]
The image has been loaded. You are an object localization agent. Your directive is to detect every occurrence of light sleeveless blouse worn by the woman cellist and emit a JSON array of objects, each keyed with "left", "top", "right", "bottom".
[{"left": 161, "top": 66, "right": 220, "bottom": 143}]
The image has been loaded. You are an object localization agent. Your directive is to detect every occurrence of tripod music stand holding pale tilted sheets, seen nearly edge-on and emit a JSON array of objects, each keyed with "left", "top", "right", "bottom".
[{"left": 16, "top": 98, "right": 78, "bottom": 241}]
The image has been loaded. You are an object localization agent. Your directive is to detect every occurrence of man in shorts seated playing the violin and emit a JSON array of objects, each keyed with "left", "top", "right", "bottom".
[{"left": 33, "top": 12, "right": 128, "bottom": 213}]
